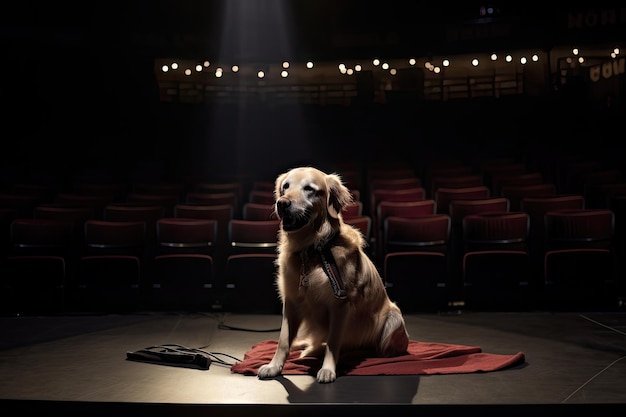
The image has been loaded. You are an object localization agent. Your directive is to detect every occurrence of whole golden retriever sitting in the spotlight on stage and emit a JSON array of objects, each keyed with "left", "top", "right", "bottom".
[{"left": 257, "top": 167, "right": 409, "bottom": 383}]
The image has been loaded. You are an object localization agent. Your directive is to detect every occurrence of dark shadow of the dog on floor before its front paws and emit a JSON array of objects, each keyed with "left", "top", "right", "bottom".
[{"left": 276, "top": 375, "right": 419, "bottom": 404}]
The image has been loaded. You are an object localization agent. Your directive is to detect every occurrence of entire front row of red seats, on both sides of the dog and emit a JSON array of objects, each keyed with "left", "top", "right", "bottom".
[{"left": 4, "top": 196, "right": 618, "bottom": 309}]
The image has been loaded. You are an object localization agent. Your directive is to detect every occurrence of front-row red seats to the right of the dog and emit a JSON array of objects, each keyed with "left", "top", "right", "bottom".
[{"left": 381, "top": 208, "right": 623, "bottom": 310}]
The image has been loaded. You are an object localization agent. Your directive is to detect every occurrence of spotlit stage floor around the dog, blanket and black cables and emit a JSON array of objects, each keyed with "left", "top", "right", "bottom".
[{"left": 0, "top": 311, "right": 626, "bottom": 416}]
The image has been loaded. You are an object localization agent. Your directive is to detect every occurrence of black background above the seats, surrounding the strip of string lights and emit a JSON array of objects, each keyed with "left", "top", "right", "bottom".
[{"left": 0, "top": 0, "right": 626, "bottom": 182}]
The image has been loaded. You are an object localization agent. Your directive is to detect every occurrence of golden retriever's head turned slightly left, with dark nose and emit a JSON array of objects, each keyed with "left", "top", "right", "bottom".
[{"left": 274, "top": 167, "right": 352, "bottom": 232}]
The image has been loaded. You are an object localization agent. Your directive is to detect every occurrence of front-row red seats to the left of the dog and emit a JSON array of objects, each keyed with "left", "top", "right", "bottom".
[{"left": 0, "top": 213, "right": 280, "bottom": 313}]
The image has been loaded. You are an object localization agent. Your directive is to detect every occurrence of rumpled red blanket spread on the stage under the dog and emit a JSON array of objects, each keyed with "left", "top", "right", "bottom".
[{"left": 230, "top": 340, "right": 525, "bottom": 375}]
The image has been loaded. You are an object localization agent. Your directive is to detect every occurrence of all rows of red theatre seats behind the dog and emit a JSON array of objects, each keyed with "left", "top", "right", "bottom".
[{"left": 4, "top": 154, "right": 622, "bottom": 312}]
